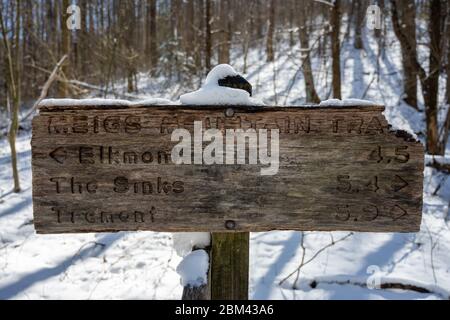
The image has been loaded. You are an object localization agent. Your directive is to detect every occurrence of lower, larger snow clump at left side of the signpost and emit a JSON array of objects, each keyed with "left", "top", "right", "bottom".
[{"left": 177, "top": 250, "right": 209, "bottom": 287}]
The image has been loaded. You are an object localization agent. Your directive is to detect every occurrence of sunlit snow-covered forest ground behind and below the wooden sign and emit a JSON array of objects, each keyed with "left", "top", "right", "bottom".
[{"left": 0, "top": 28, "right": 450, "bottom": 299}]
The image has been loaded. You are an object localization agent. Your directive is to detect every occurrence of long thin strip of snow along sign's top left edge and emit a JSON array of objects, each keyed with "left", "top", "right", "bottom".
[{"left": 39, "top": 98, "right": 174, "bottom": 107}]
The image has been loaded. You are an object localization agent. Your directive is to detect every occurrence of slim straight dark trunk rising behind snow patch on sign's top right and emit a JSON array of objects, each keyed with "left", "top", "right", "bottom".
[{"left": 331, "top": 0, "right": 342, "bottom": 99}]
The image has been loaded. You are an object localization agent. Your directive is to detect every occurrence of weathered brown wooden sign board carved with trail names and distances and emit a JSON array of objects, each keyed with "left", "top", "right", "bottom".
[{"left": 32, "top": 105, "right": 424, "bottom": 233}]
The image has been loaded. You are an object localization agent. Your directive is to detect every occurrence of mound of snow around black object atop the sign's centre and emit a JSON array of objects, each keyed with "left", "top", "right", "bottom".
[{"left": 180, "top": 64, "right": 264, "bottom": 106}]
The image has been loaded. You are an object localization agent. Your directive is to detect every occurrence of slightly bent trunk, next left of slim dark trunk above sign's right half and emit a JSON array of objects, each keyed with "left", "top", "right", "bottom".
[{"left": 299, "top": 4, "right": 320, "bottom": 103}]
